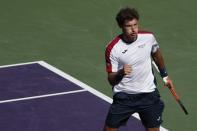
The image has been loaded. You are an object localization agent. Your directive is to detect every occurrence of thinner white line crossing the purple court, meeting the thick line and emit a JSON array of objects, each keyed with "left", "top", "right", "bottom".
[{"left": 0, "top": 89, "right": 87, "bottom": 104}]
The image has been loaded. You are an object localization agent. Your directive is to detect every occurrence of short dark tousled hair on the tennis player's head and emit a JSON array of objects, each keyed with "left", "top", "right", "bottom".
[{"left": 116, "top": 7, "right": 139, "bottom": 27}]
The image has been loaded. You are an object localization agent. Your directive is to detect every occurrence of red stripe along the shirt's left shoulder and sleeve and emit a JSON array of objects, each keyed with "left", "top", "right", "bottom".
[{"left": 105, "top": 36, "right": 120, "bottom": 72}]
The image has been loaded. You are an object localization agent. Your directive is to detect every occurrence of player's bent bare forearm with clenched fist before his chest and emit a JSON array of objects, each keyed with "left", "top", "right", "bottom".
[{"left": 108, "top": 65, "right": 132, "bottom": 86}]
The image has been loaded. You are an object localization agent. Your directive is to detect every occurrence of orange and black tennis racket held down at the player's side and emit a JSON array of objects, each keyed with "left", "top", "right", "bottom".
[{"left": 152, "top": 61, "right": 188, "bottom": 115}]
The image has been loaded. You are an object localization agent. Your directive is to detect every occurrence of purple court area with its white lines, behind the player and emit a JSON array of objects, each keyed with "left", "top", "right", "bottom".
[{"left": 0, "top": 61, "right": 167, "bottom": 131}]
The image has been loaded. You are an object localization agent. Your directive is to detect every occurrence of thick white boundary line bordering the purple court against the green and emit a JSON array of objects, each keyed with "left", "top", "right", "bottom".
[{"left": 0, "top": 61, "right": 169, "bottom": 131}]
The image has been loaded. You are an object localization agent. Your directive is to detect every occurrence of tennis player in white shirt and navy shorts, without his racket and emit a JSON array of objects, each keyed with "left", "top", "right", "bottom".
[{"left": 104, "top": 7, "right": 172, "bottom": 131}]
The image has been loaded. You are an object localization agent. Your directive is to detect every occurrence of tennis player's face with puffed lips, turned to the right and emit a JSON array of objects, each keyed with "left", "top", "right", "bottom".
[{"left": 122, "top": 19, "right": 139, "bottom": 41}]
